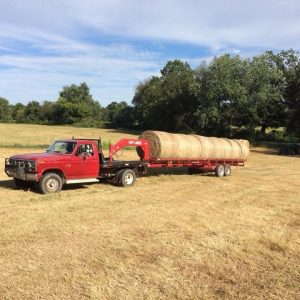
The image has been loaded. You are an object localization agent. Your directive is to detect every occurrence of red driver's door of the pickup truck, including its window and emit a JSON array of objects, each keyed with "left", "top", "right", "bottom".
[{"left": 70, "top": 143, "right": 99, "bottom": 179}]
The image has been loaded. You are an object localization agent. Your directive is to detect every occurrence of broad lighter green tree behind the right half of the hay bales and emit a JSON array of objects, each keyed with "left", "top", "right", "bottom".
[{"left": 195, "top": 54, "right": 251, "bottom": 136}]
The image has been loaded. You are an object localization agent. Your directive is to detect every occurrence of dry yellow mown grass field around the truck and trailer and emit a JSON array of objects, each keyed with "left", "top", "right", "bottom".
[{"left": 0, "top": 124, "right": 300, "bottom": 299}]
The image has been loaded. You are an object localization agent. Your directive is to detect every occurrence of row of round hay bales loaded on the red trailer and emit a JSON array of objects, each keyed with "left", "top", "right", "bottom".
[{"left": 138, "top": 130, "right": 250, "bottom": 160}]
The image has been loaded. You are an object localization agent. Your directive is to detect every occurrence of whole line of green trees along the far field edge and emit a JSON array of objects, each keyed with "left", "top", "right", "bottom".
[{"left": 0, "top": 49, "right": 300, "bottom": 137}]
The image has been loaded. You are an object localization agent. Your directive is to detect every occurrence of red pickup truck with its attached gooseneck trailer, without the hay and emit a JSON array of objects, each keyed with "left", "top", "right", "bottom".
[{"left": 5, "top": 138, "right": 244, "bottom": 194}]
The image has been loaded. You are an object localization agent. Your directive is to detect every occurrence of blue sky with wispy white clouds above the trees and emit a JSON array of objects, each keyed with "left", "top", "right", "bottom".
[{"left": 0, "top": 0, "right": 300, "bottom": 106}]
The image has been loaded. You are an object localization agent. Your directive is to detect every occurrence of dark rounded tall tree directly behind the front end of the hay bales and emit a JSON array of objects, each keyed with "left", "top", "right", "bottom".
[{"left": 133, "top": 60, "right": 196, "bottom": 132}]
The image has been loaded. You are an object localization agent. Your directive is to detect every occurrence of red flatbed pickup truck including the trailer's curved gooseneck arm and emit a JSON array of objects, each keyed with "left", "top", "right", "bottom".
[{"left": 5, "top": 138, "right": 147, "bottom": 194}]
